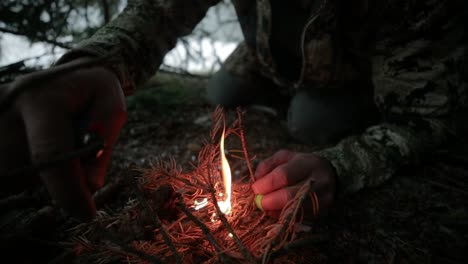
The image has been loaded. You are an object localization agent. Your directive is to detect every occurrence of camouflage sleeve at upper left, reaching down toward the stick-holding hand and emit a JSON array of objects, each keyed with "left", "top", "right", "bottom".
[{"left": 57, "top": 0, "right": 219, "bottom": 94}]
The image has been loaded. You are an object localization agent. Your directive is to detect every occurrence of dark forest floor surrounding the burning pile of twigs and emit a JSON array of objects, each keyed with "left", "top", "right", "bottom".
[{"left": 0, "top": 71, "right": 468, "bottom": 263}]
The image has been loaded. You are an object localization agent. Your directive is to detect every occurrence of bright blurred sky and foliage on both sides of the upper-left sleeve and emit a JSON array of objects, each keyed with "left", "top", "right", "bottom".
[{"left": 0, "top": 0, "right": 242, "bottom": 79}]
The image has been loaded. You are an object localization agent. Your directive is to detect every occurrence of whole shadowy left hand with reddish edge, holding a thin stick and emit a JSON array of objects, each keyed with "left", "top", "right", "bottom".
[{"left": 0, "top": 58, "right": 127, "bottom": 219}]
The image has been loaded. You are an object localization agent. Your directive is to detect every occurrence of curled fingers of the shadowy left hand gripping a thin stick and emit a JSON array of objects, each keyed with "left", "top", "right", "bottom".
[{"left": 11, "top": 63, "right": 126, "bottom": 219}]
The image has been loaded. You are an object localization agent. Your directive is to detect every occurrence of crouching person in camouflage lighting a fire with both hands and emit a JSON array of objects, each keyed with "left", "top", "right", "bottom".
[{"left": 0, "top": 0, "right": 468, "bottom": 221}]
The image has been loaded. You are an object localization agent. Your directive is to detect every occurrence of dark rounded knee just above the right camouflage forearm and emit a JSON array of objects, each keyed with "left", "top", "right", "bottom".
[{"left": 288, "top": 83, "right": 379, "bottom": 147}]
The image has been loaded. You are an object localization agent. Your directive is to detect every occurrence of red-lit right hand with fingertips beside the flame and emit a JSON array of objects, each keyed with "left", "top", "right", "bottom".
[{"left": 252, "top": 150, "right": 336, "bottom": 218}]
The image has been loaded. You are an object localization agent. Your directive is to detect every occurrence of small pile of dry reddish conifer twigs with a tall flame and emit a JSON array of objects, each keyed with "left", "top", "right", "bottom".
[{"left": 71, "top": 108, "right": 317, "bottom": 263}]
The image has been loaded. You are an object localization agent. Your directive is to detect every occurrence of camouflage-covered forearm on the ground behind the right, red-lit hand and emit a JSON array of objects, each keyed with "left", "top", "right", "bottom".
[{"left": 316, "top": 119, "right": 451, "bottom": 196}]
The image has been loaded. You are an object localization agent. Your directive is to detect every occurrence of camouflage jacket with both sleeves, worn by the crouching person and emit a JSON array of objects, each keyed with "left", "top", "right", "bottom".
[{"left": 58, "top": 0, "right": 468, "bottom": 194}]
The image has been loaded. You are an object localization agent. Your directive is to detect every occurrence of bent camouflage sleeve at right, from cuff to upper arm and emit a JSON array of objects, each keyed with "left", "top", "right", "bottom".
[{"left": 316, "top": 35, "right": 467, "bottom": 196}]
